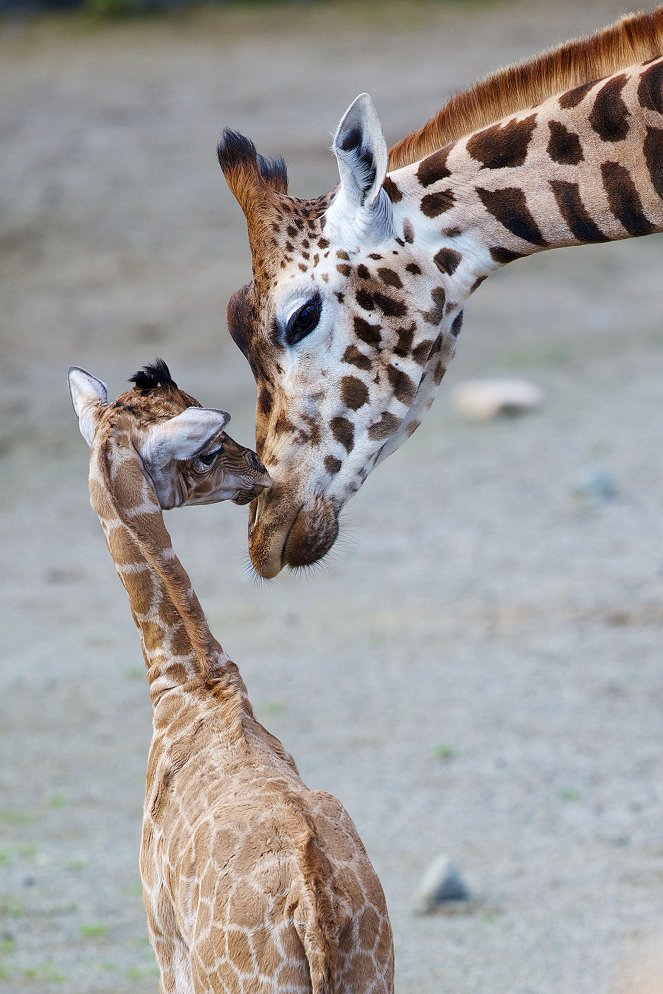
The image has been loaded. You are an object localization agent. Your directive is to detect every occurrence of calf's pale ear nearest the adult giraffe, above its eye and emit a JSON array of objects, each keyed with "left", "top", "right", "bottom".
[{"left": 138, "top": 407, "right": 230, "bottom": 468}]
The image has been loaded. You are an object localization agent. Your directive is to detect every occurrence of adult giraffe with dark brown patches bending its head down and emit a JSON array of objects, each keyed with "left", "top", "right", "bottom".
[{"left": 218, "top": 7, "right": 663, "bottom": 577}]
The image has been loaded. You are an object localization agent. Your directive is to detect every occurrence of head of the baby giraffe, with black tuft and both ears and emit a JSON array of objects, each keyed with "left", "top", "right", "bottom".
[{"left": 69, "top": 360, "right": 271, "bottom": 508}]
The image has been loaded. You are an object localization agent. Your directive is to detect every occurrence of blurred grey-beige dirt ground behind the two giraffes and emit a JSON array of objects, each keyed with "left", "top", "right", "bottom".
[{"left": 0, "top": 0, "right": 663, "bottom": 994}]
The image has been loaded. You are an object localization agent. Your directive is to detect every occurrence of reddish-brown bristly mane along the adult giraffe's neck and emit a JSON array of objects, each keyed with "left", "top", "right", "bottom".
[{"left": 389, "top": 7, "right": 663, "bottom": 169}]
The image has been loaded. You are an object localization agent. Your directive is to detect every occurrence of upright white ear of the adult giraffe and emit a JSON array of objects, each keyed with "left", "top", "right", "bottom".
[{"left": 326, "top": 93, "right": 392, "bottom": 241}]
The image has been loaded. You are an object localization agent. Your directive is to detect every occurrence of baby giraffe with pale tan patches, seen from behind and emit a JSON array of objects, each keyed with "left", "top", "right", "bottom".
[{"left": 69, "top": 360, "right": 393, "bottom": 994}]
